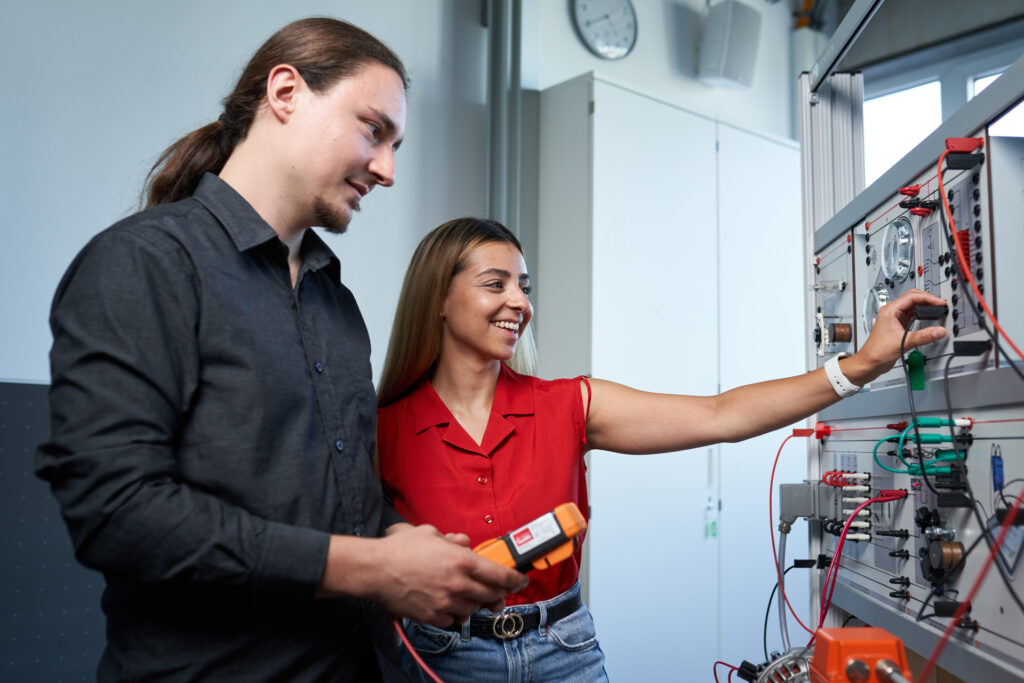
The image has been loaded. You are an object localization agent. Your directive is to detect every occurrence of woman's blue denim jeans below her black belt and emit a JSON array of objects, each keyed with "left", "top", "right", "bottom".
[{"left": 401, "top": 583, "right": 608, "bottom": 683}]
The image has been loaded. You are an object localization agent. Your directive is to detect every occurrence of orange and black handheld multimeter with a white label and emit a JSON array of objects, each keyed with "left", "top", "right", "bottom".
[{"left": 473, "top": 503, "right": 587, "bottom": 571}]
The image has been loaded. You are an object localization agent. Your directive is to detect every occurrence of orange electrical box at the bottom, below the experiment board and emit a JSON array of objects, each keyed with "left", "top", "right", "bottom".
[{"left": 811, "top": 627, "right": 913, "bottom": 683}]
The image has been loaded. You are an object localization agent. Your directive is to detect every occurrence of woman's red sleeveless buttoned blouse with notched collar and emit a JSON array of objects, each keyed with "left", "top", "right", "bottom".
[{"left": 377, "top": 364, "right": 589, "bottom": 605}]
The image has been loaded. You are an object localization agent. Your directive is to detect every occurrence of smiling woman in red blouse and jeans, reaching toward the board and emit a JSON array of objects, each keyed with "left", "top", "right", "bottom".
[{"left": 377, "top": 218, "right": 945, "bottom": 683}]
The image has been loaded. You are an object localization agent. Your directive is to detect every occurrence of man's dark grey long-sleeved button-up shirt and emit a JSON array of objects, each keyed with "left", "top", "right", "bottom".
[{"left": 36, "top": 174, "right": 397, "bottom": 681}]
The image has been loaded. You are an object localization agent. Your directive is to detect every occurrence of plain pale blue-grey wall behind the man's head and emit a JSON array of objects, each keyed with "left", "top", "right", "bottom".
[{"left": 0, "top": 0, "right": 486, "bottom": 382}]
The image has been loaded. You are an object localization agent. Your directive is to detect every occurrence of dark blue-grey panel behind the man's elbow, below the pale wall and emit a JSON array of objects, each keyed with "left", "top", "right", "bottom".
[{"left": 0, "top": 382, "right": 105, "bottom": 681}]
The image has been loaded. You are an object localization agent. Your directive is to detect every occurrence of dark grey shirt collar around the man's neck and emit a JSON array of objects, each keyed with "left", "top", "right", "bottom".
[{"left": 193, "top": 173, "right": 341, "bottom": 284}]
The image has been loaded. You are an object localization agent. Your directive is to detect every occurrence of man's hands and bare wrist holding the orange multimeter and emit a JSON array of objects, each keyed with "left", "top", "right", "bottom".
[{"left": 318, "top": 524, "right": 527, "bottom": 627}]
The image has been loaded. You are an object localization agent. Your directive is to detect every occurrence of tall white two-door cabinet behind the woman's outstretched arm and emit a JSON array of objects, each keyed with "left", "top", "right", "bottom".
[{"left": 535, "top": 75, "right": 803, "bottom": 681}]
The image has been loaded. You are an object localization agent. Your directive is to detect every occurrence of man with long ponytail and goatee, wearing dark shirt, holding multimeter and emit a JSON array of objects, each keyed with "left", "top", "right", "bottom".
[{"left": 37, "top": 18, "right": 525, "bottom": 681}]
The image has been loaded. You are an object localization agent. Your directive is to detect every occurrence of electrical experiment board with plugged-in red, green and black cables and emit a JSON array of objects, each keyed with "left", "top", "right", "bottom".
[{"left": 807, "top": 80, "right": 1024, "bottom": 681}]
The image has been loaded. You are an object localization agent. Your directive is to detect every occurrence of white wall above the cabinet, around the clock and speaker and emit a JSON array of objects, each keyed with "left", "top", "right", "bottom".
[{"left": 522, "top": 0, "right": 797, "bottom": 140}]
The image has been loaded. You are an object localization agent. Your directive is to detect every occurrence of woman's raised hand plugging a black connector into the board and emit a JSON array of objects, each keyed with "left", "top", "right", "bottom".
[{"left": 842, "top": 290, "right": 946, "bottom": 386}]
